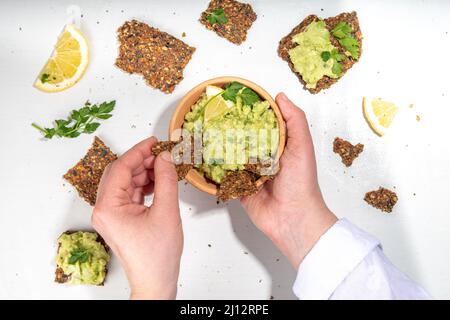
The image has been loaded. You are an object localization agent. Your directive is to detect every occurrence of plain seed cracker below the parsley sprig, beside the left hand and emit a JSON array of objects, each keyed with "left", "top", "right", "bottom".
[{"left": 64, "top": 137, "right": 117, "bottom": 206}]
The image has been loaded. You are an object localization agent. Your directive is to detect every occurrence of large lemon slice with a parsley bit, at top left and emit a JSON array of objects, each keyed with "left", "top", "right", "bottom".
[{"left": 34, "top": 24, "right": 89, "bottom": 92}]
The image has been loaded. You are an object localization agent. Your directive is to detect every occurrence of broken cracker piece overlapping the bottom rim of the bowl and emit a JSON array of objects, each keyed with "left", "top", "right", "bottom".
[{"left": 217, "top": 171, "right": 258, "bottom": 202}]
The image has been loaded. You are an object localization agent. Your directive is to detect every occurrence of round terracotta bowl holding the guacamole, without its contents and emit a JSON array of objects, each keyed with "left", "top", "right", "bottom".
[{"left": 169, "top": 77, "right": 286, "bottom": 195}]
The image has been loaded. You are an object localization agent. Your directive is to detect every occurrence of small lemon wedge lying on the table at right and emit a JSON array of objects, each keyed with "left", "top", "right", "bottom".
[{"left": 363, "top": 97, "right": 398, "bottom": 136}]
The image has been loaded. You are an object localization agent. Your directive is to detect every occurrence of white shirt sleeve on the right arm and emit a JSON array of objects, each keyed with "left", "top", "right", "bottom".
[{"left": 293, "top": 219, "right": 430, "bottom": 299}]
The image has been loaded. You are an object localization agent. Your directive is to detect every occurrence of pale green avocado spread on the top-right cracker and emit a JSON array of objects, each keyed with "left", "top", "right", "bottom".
[{"left": 289, "top": 20, "right": 338, "bottom": 89}]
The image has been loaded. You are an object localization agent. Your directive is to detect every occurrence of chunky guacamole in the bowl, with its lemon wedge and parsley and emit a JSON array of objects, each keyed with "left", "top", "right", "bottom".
[{"left": 182, "top": 81, "right": 279, "bottom": 185}]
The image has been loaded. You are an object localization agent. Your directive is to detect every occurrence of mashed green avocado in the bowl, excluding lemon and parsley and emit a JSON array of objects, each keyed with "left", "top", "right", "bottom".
[{"left": 183, "top": 87, "right": 279, "bottom": 184}]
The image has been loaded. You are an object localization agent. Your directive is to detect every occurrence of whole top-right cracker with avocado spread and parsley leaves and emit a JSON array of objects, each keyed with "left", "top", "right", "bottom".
[{"left": 278, "top": 11, "right": 362, "bottom": 94}]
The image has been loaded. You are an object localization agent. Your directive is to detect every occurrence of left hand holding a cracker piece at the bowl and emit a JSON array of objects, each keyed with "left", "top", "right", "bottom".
[{"left": 92, "top": 137, "right": 183, "bottom": 299}]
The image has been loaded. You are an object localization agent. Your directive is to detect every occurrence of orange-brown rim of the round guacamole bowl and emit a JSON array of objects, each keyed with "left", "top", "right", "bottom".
[{"left": 168, "top": 76, "right": 286, "bottom": 195}]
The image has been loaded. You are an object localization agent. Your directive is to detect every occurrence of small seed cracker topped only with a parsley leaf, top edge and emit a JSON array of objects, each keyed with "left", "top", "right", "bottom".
[{"left": 200, "top": 0, "right": 256, "bottom": 45}]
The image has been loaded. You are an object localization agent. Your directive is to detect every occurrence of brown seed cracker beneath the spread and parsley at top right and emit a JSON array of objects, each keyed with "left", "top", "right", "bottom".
[{"left": 278, "top": 11, "right": 363, "bottom": 94}]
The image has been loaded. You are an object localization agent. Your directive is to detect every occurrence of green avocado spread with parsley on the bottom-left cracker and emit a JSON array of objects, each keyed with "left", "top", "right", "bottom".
[{"left": 56, "top": 231, "right": 110, "bottom": 285}]
